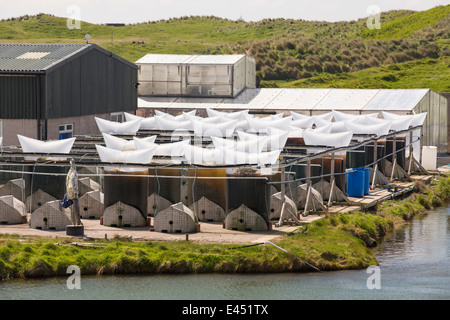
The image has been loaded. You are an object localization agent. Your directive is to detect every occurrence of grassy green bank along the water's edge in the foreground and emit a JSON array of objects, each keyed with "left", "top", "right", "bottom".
[{"left": 0, "top": 177, "right": 450, "bottom": 279}]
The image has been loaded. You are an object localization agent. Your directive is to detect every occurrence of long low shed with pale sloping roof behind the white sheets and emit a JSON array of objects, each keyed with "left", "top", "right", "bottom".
[{"left": 137, "top": 88, "right": 448, "bottom": 153}]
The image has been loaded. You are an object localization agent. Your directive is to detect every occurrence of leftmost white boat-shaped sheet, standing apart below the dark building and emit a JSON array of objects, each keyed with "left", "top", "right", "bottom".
[{"left": 17, "top": 134, "right": 76, "bottom": 154}]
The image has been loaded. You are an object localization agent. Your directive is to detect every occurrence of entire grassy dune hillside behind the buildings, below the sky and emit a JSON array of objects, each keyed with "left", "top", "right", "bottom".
[{"left": 0, "top": 5, "right": 450, "bottom": 92}]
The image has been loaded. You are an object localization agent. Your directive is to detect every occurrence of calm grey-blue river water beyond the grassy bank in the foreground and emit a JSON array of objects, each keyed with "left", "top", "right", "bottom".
[{"left": 0, "top": 207, "right": 450, "bottom": 300}]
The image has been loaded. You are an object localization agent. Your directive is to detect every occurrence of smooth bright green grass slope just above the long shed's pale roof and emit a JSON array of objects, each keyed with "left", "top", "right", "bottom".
[{"left": 280, "top": 57, "right": 450, "bottom": 92}]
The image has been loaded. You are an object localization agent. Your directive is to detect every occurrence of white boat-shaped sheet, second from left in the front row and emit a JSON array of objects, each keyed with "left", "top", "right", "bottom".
[{"left": 95, "top": 144, "right": 156, "bottom": 164}]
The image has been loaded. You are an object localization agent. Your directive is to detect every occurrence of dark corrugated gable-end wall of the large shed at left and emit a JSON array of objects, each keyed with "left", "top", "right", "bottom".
[{"left": 43, "top": 50, "right": 138, "bottom": 119}]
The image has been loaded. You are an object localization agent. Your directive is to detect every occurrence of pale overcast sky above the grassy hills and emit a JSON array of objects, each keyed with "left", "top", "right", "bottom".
[{"left": 0, "top": 0, "right": 450, "bottom": 24}]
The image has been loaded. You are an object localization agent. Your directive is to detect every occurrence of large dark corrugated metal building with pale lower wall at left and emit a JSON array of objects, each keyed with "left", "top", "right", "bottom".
[{"left": 0, "top": 43, "right": 138, "bottom": 145}]
